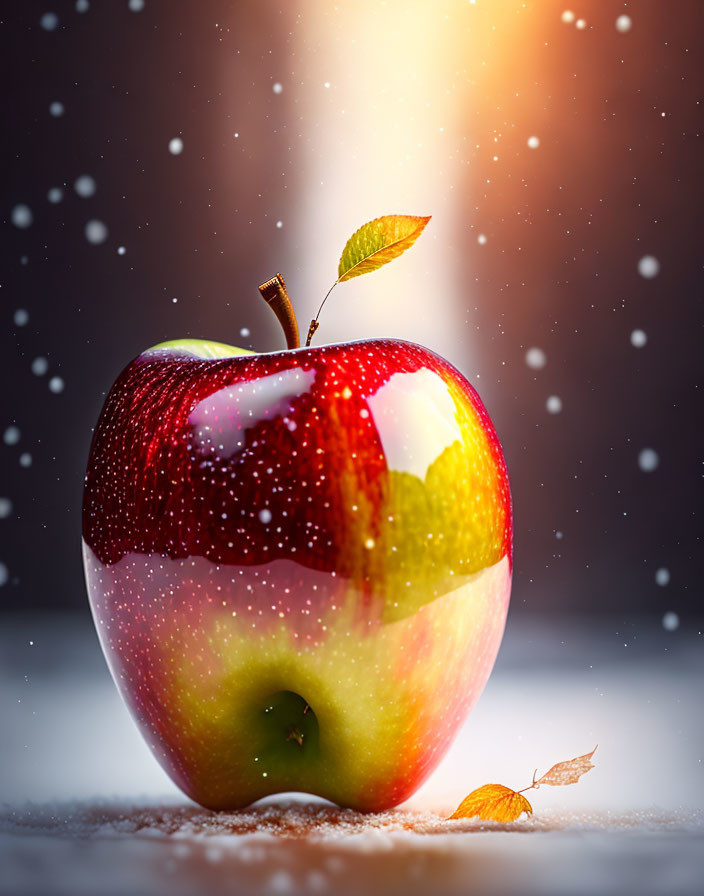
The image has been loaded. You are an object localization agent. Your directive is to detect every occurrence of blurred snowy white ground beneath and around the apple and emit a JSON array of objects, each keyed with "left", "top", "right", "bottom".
[{"left": 0, "top": 617, "right": 704, "bottom": 896}]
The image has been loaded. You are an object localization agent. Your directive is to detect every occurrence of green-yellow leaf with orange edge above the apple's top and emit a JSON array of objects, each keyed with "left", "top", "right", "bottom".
[{"left": 337, "top": 215, "right": 430, "bottom": 283}]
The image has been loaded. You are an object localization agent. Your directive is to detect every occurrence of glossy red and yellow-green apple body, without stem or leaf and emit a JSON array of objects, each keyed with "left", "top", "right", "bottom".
[{"left": 83, "top": 339, "right": 512, "bottom": 811}]
